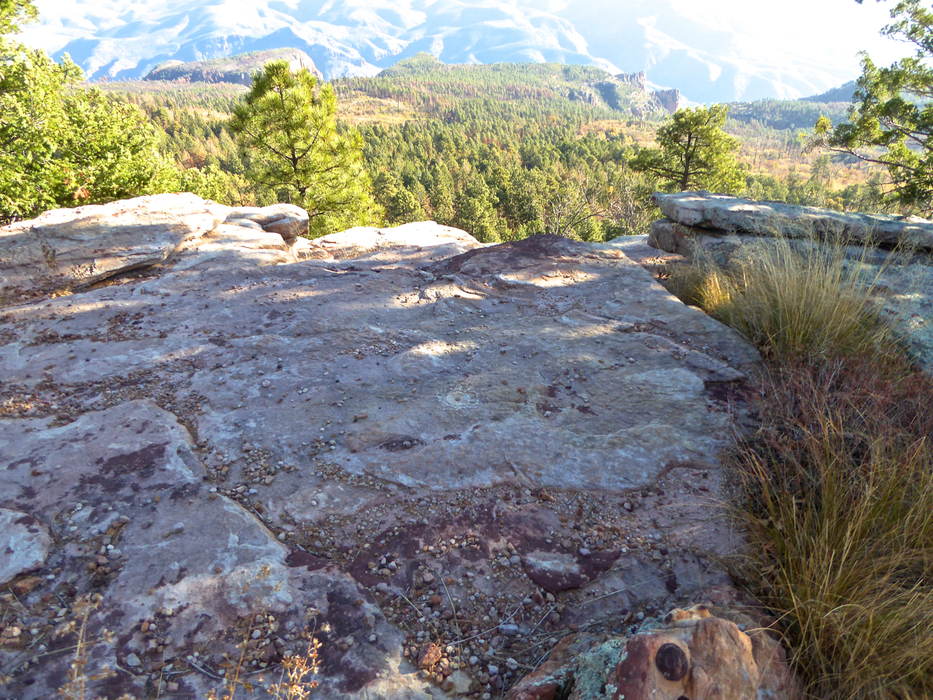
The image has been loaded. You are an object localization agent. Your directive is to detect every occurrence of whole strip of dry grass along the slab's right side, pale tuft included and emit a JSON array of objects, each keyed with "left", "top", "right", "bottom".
[{"left": 693, "top": 228, "right": 933, "bottom": 700}]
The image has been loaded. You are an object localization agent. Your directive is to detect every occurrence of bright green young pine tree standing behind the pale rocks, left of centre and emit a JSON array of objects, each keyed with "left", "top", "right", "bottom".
[{"left": 230, "top": 61, "right": 380, "bottom": 235}]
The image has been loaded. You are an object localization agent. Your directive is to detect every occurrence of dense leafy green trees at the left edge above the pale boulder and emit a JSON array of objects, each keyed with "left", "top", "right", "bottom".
[{"left": 0, "top": 40, "right": 163, "bottom": 222}]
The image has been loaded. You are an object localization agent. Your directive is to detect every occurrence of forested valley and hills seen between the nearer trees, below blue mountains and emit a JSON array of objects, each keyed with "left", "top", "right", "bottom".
[{"left": 5, "top": 45, "right": 896, "bottom": 241}]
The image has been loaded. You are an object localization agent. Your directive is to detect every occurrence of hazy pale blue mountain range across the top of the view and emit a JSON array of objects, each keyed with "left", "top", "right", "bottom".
[{"left": 23, "top": 0, "right": 868, "bottom": 102}]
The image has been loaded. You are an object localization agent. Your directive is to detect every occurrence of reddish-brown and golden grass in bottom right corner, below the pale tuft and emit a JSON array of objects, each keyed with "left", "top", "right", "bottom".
[{"left": 732, "top": 356, "right": 933, "bottom": 699}]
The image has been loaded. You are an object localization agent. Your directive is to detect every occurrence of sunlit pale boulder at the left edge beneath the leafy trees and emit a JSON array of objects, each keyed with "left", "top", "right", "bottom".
[{"left": 0, "top": 193, "right": 321, "bottom": 305}]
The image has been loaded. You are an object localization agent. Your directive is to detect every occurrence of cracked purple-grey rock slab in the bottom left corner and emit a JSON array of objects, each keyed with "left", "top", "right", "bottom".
[{"left": 0, "top": 400, "right": 414, "bottom": 700}]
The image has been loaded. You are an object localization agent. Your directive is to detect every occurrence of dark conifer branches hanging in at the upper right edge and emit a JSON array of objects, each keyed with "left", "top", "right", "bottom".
[{"left": 810, "top": 0, "right": 933, "bottom": 213}]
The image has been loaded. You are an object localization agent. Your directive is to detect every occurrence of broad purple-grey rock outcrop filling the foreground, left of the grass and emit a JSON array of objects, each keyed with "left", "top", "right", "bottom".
[{"left": 0, "top": 195, "right": 792, "bottom": 700}]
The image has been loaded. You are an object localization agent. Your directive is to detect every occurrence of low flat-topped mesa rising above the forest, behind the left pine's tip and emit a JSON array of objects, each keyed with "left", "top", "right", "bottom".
[{"left": 144, "top": 49, "right": 323, "bottom": 85}]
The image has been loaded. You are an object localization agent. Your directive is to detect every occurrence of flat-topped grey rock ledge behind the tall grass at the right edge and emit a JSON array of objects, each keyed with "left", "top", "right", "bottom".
[{"left": 648, "top": 192, "right": 933, "bottom": 368}]
